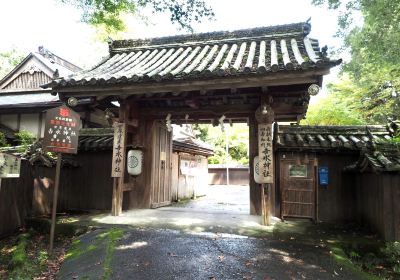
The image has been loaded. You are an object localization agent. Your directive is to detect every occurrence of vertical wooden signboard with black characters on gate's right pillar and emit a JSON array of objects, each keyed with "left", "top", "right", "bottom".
[{"left": 258, "top": 124, "right": 274, "bottom": 184}]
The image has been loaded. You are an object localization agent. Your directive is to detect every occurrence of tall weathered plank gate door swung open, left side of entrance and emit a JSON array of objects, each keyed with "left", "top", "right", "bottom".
[{"left": 151, "top": 123, "right": 172, "bottom": 208}]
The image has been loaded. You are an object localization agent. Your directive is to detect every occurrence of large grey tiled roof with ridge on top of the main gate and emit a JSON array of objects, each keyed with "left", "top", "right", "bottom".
[{"left": 46, "top": 23, "right": 340, "bottom": 87}]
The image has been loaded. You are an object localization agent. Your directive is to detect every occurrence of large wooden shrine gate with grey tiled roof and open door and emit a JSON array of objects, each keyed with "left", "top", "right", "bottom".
[{"left": 45, "top": 23, "right": 341, "bottom": 219}]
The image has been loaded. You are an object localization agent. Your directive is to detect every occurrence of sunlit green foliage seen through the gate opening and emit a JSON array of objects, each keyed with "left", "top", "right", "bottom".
[{"left": 194, "top": 124, "right": 249, "bottom": 165}]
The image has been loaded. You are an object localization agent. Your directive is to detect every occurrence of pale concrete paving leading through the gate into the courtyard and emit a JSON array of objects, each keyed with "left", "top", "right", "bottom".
[{"left": 90, "top": 186, "right": 272, "bottom": 236}]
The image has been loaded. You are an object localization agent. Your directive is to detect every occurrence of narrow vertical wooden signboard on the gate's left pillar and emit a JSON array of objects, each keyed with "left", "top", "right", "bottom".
[{"left": 111, "top": 123, "right": 126, "bottom": 178}]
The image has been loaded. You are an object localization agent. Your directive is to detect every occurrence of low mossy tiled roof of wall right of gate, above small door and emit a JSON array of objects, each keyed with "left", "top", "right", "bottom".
[{"left": 275, "top": 125, "right": 392, "bottom": 150}]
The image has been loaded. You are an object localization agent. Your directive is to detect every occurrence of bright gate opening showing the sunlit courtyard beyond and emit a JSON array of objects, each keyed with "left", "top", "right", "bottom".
[{"left": 171, "top": 120, "right": 250, "bottom": 215}]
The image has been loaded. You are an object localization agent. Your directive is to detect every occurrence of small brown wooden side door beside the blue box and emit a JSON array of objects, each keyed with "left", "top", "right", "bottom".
[{"left": 280, "top": 159, "right": 316, "bottom": 219}]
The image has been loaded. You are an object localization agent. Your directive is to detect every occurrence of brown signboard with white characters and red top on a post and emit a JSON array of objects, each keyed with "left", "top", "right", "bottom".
[{"left": 43, "top": 105, "right": 80, "bottom": 154}]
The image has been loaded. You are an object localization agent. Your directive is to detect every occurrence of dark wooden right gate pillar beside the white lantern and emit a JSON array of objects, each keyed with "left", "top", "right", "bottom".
[{"left": 249, "top": 116, "right": 261, "bottom": 215}]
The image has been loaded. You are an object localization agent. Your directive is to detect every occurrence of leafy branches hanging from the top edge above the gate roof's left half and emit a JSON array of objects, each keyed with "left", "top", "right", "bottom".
[{"left": 58, "top": 0, "right": 214, "bottom": 32}]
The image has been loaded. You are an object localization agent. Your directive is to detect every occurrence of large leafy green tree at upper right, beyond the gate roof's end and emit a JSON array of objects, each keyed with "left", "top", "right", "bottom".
[{"left": 313, "top": 0, "right": 400, "bottom": 123}]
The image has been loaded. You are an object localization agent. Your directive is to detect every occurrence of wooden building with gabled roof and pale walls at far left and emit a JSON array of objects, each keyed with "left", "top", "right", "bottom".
[{"left": 0, "top": 47, "right": 108, "bottom": 142}]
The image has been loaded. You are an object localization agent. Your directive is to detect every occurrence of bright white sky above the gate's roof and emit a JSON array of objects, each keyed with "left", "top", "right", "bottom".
[{"left": 0, "top": 0, "right": 341, "bottom": 97}]
